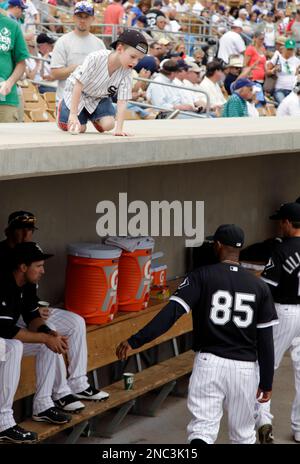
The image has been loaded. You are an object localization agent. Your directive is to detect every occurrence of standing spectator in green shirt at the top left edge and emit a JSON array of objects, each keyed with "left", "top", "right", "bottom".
[{"left": 0, "top": 13, "right": 29, "bottom": 123}]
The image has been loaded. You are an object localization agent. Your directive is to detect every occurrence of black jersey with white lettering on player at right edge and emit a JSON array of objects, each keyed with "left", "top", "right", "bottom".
[{"left": 262, "top": 237, "right": 300, "bottom": 304}]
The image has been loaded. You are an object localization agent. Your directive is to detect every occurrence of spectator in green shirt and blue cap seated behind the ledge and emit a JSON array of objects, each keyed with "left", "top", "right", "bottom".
[{"left": 222, "top": 78, "right": 254, "bottom": 118}]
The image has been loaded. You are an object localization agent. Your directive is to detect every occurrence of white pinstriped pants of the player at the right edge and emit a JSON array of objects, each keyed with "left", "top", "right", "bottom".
[{"left": 255, "top": 303, "right": 300, "bottom": 432}]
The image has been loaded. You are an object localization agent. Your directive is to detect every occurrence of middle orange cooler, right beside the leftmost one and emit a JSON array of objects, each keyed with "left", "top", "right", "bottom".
[{"left": 118, "top": 239, "right": 154, "bottom": 311}]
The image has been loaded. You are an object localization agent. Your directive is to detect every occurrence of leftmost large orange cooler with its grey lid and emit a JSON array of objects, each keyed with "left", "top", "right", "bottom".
[{"left": 65, "top": 243, "right": 121, "bottom": 324}]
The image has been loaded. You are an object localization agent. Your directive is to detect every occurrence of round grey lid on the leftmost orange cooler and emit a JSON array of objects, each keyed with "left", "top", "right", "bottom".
[{"left": 67, "top": 242, "right": 122, "bottom": 259}]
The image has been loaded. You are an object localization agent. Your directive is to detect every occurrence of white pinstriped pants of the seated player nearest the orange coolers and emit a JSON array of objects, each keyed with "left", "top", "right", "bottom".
[{"left": 18, "top": 308, "right": 89, "bottom": 400}]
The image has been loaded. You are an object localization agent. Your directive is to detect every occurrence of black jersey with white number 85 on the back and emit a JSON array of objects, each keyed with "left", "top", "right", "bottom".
[{"left": 171, "top": 262, "right": 278, "bottom": 361}]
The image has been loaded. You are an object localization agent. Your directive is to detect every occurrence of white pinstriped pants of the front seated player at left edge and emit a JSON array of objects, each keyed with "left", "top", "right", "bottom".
[{"left": 0, "top": 339, "right": 57, "bottom": 431}]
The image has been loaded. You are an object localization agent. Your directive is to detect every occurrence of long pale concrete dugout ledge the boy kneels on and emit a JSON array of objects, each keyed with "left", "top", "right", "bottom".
[{"left": 0, "top": 117, "right": 300, "bottom": 180}]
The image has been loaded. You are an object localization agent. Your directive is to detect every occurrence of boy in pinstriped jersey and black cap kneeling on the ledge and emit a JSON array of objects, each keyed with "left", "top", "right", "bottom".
[{"left": 57, "top": 30, "right": 148, "bottom": 136}]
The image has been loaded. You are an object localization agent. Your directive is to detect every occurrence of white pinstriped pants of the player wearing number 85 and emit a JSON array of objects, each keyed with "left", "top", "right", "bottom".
[{"left": 187, "top": 353, "right": 257, "bottom": 444}]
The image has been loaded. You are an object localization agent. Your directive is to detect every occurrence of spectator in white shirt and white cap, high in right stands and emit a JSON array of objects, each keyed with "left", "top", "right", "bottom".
[{"left": 218, "top": 19, "right": 246, "bottom": 64}]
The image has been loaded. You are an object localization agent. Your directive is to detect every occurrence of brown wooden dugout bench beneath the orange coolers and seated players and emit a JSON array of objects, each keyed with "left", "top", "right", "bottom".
[{"left": 15, "top": 281, "right": 194, "bottom": 443}]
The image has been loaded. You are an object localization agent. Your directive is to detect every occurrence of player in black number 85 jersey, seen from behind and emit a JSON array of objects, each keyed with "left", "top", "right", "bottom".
[{"left": 117, "top": 224, "right": 278, "bottom": 446}]
